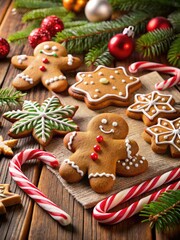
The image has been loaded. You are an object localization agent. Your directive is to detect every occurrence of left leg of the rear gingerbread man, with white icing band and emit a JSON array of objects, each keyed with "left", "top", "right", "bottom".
[{"left": 12, "top": 66, "right": 41, "bottom": 91}]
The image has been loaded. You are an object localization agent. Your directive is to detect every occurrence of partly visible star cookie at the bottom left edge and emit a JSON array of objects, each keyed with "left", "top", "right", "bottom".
[{"left": 0, "top": 184, "right": 21, "bottom": 214}]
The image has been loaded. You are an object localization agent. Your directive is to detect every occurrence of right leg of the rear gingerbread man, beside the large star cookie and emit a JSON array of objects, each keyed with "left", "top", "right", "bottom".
[{"left": 42, "top": 69, "right": 68, "bottom": 93}]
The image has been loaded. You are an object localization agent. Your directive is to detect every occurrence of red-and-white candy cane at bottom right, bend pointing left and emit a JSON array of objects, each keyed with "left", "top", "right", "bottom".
[{"left": 93, "top": 168, "right": 180, "bottom": 224}]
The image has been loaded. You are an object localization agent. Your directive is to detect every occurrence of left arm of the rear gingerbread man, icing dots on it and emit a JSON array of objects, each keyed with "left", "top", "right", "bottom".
[{"left": 11, "top": 54, "right": 35, "bottom": 69}]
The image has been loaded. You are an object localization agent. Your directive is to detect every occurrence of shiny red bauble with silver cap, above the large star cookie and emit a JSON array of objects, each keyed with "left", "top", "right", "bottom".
[{"left": 108, "top": 26, "right": 134, "bottom": 60}]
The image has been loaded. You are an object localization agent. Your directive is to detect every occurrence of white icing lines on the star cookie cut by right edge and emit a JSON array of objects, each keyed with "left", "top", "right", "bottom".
[{"left": 146, "top": 118, "right": 180, "bottom": 151}]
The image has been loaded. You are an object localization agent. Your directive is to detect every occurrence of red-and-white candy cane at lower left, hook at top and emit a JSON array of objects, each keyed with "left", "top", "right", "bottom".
[{"left": 9, "top": 149, "right": 71, "bottom": 226}]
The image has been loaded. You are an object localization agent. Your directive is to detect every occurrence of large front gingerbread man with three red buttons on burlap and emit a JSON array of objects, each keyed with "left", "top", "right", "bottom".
[{"left": 59, "top": 113, "right": 148, "bottom": 193}]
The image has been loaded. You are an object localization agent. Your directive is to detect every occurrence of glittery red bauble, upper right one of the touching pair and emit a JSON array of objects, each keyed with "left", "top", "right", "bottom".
[{"left": 41, "top": 15, "right": 64, "bottom": 37}]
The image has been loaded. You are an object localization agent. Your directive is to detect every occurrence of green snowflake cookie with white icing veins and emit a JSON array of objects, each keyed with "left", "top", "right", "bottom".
[{"left": 3, "top": 96, "right": 78, "bottom": 146}]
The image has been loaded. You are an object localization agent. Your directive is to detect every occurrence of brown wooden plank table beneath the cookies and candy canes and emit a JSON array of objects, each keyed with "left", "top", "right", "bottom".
[{"left": 0, "top": 0, "right": 180, "bottom": 240}]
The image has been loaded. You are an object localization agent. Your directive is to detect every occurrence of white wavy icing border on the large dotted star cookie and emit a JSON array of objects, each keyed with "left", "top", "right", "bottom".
[{"left": 71, "top": 65, "right": 140, "bottom": 103}]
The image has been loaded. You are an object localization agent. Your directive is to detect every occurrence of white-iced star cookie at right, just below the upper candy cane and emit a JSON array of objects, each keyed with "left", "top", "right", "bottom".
[{"left": 126, "top": 91, "right": 180, "bottom": 126}]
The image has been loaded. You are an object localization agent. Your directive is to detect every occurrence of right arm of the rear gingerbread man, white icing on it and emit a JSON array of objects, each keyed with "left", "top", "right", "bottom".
[{"left": 59, "top": 54, "right": 81, "bottom": 71}]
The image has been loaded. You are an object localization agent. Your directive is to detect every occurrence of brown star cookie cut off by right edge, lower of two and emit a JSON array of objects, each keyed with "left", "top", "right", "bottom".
[{"left": 143, "top": 117, "right": 180, "bottom": 158}]
